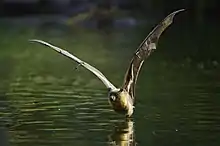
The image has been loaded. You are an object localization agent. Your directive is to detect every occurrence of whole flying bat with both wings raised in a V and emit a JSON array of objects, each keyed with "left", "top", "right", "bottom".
[{"left": 30, "top": 10, "right": 183, "bottom": 117}]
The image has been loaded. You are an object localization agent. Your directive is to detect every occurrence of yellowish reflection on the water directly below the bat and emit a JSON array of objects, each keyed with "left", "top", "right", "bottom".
[{"left": 109, "top": 119, "right": 136, "bottom": 146}]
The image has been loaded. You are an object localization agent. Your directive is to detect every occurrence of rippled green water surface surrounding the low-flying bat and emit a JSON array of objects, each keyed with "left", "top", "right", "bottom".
[{"left": 0, "top": 20, "right": 220, "bottom": 146}]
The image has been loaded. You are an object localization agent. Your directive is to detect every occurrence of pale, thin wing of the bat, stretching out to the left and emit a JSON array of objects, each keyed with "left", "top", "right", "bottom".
[{"left": 29, "top": 39, "right": 116, "bottom": 90}]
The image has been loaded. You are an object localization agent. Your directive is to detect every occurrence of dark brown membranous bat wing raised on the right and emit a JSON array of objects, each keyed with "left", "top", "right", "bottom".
[{"left": 122, "top": 9, "right": 183, "bottom": 100}]
